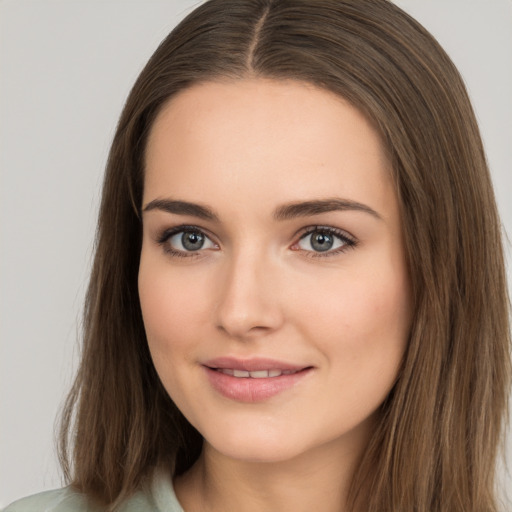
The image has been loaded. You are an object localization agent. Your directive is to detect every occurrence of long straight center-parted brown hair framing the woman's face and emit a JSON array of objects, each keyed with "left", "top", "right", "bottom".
[{"left": 61, "top": 0, "right": 510, "bottom": 512}]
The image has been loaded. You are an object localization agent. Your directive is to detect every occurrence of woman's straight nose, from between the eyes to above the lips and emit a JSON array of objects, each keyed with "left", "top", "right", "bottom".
[{"left": 215, "top": 249, "right": 283, "bottom": 340}]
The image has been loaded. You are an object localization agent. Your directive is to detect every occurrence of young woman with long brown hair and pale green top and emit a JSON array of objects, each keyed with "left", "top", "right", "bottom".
[{"left": 7, "top": 0, "right": 510, "bottom": 512}]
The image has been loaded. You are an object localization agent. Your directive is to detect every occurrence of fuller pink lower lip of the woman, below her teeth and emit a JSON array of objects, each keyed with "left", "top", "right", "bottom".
[{"left": 204, "top": 366, "right": 312, "bottom": 403}]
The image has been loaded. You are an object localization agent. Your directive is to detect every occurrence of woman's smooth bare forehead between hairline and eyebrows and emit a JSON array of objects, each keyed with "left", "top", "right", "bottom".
[{"left": 144, "top": 79, "right": 394, "bottom": 220}]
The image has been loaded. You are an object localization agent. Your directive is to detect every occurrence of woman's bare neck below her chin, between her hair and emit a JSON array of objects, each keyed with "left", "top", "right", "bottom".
[{"left": 175, "top": 424, "right": 368, "bottom": 512}]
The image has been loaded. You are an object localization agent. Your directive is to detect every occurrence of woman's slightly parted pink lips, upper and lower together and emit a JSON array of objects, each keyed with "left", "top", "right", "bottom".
[{"left": 203, "top": 357, "right": 313, "bottom": 403}]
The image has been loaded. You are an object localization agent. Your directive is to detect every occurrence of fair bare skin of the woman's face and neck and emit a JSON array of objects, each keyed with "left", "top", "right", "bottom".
[{"left": 139, "top": 79, "right": 410, "bottom": 512}]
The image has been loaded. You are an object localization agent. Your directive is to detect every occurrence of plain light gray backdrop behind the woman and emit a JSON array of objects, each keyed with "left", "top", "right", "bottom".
[{"left": 0, "top": 0, "right": 512, "bottom": 507}]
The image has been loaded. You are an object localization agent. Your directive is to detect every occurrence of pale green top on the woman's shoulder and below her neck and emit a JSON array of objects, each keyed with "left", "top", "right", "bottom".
[{"left": 3, "top": 474, "right": 184, "bottom": 512}]
